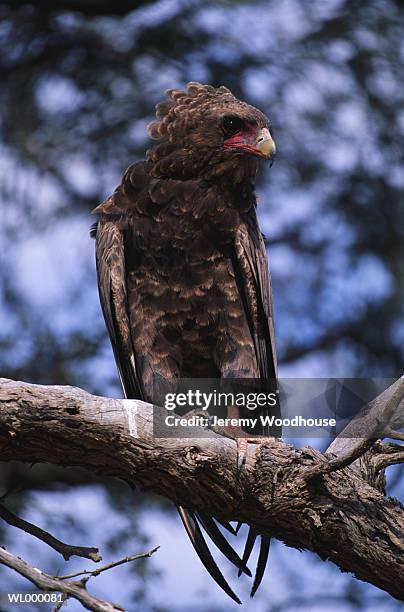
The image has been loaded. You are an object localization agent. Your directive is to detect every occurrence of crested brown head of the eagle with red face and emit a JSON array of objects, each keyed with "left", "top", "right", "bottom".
[{"left": 147, "top": 83, "right": 276, "bottom": 179}]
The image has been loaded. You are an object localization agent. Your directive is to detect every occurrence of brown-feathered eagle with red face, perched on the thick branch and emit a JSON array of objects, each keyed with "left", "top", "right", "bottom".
[{"left": 94, "top": 83, "right": 276, "bottom": 601}]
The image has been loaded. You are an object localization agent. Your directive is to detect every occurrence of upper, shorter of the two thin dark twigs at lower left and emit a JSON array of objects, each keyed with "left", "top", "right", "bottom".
[{"left": 0, "top": 503, "right": 102, "bottom": 562}]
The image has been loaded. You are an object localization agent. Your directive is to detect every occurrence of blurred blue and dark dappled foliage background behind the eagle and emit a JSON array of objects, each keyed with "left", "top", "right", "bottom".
[{"left": 0, "top": 0, "right": 404, "bottom": 612}]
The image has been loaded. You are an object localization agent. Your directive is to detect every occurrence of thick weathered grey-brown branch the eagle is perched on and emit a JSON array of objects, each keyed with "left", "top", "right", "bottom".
[{"left": 0, "top": 379, "right": 404, "bottom": 599}]
